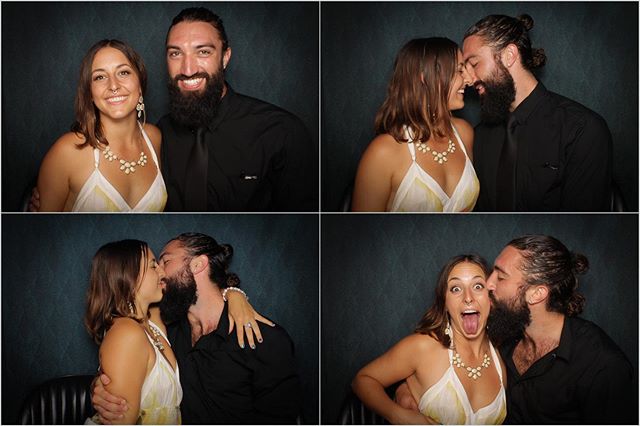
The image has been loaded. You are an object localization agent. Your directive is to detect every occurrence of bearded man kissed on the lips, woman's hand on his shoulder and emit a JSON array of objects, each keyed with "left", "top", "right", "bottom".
[{"left": 93, "top": 233, "right": 300, "bottom": 424}]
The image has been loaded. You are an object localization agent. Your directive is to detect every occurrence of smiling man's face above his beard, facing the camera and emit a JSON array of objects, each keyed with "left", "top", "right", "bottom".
[{"left": 167, "top": 21, "right": 231, "bottom": 93}]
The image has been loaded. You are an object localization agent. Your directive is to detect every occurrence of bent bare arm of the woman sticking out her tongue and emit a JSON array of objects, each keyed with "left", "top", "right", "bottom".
[{"left": 351, "top": 334, "right": 436, "bottom": 424}]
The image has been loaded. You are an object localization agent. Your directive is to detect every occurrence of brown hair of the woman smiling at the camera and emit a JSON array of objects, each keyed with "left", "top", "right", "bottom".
[{"left": 71, "top": 39, "right": 147, "bottom": 148}]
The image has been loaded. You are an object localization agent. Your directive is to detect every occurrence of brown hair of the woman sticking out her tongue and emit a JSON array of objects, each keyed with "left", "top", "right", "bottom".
[{"left": 414, "top": 254, "right": 490, "bottom": 348}]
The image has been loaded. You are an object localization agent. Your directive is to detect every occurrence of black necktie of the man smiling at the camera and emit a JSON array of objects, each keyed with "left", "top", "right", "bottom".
[{"left": 184, "top": 128, "right": 209, "bottom": 212}]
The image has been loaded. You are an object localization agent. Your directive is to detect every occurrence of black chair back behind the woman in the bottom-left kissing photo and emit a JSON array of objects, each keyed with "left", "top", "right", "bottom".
[{"left": 20, "top": 375, "right": 94, "bottom": 425}]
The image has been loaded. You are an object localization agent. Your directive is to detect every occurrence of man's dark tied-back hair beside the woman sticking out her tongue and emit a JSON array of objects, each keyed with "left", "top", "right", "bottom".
[{"left": 507, "top": 235, "right": 589, "bottom": 316}]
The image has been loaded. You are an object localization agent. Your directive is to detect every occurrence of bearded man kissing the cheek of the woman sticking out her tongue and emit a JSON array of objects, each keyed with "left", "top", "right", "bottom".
[{"left": 398, "top": 235, "right": 638, "bottom": 424}]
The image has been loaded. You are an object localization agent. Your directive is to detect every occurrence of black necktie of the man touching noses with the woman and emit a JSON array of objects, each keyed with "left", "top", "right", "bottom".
[{"left": 496, "top": 114, "right": 518, "bottom": 211}]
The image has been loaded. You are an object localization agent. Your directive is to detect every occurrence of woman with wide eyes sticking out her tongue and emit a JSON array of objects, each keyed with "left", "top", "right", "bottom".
[{"left": 352, "top": 255, "right": 506, "bottom": 424}]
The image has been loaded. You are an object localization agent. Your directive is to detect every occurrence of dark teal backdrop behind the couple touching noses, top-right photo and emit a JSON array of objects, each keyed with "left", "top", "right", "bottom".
[{"left": 321, "top": 2, "right": 638, "bottom": 211}]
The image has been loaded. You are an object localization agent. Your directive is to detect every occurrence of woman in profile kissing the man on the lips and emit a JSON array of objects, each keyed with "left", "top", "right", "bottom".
[{"left": 85, "top": 240, "right": 262, "bottom": 424}]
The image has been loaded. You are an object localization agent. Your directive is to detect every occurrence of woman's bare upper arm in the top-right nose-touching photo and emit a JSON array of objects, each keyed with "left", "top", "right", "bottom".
[{"left": 351, "top": 135, "right": 397, "bottom": 212}]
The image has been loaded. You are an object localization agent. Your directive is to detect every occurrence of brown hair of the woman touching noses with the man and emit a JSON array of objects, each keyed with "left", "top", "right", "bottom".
[{"left": 375, "top": 37, "right": 459, "bottom": 142}]
